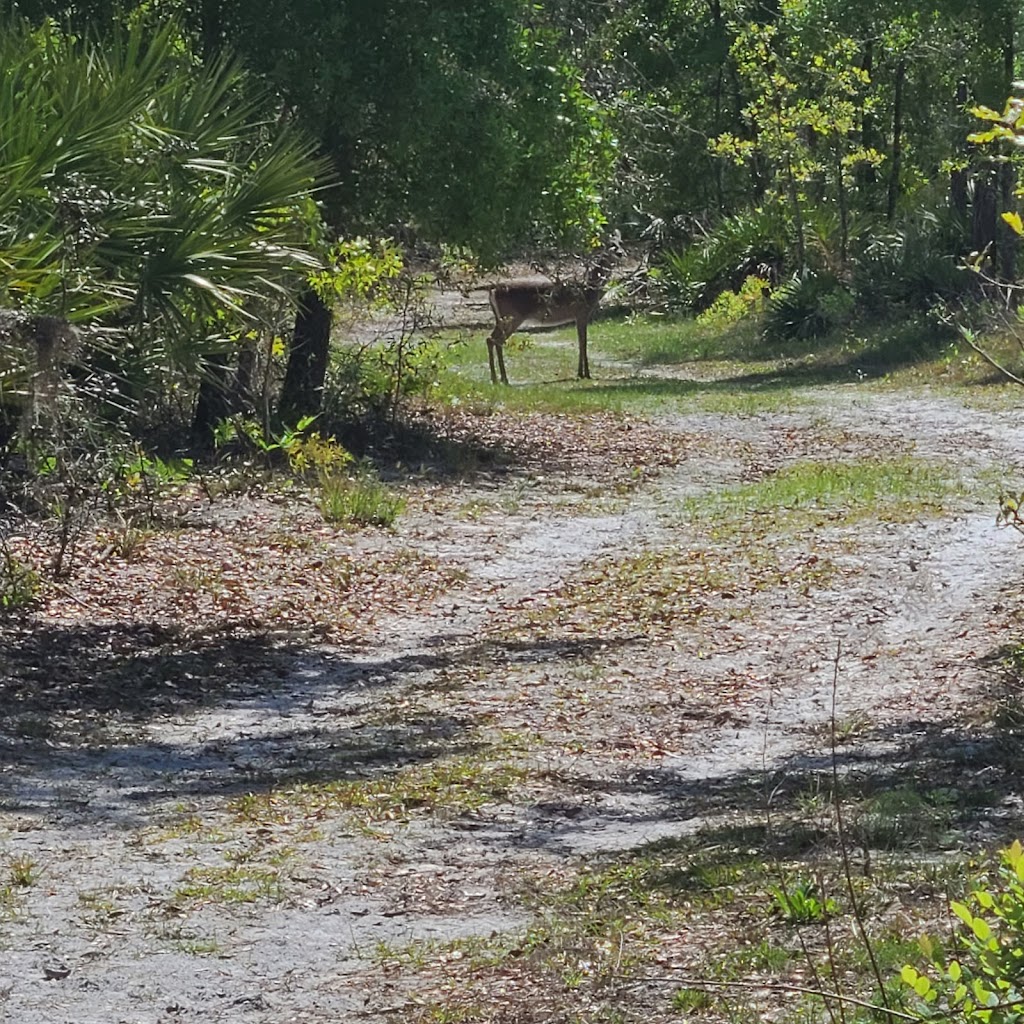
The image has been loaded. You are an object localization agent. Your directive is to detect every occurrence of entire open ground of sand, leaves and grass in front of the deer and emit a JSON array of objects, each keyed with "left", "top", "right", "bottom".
[{"left": 0, "top": 329, "right": 1024, "bottom": 1024}]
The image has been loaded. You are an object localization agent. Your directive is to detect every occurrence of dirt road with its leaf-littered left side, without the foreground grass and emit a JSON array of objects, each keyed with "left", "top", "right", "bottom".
[{"left": 0, "top": 378, "right": 1024, "bottom": 1024}]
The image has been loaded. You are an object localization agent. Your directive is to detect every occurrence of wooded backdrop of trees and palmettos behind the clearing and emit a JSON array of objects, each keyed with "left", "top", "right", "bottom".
[{"left": 0, "top": 0, "right": 1018, "bottom": 444}]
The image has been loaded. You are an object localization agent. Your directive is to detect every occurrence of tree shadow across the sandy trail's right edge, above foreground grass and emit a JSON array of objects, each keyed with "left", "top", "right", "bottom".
[{"left": 522, "top": 682, "right": 1024, "bottom": 858}]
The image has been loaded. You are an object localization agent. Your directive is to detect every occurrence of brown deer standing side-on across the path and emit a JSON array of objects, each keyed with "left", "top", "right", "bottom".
[{"left": 487, "top": 249, "right": 612, "bottom": 384}]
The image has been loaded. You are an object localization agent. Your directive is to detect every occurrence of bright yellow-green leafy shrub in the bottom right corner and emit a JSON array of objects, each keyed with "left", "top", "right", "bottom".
[{"left": 900, "top": 842, "right": 1024, "bottom": 1024}]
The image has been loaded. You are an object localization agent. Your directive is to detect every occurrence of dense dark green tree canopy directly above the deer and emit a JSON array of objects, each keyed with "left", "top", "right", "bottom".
[{"left": 203, "top": 0, "right": 615, "bottom": 260}]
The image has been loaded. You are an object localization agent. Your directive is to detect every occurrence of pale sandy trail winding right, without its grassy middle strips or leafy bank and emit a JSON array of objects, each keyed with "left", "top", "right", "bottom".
[{"left": 0, "top": 388, "right": 1024, "bottom": 1024}]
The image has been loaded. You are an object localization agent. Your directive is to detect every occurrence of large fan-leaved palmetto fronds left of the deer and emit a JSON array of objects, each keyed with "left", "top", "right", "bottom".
[{"left": 0, "top": 20, "right": 323, "bottom": 411}]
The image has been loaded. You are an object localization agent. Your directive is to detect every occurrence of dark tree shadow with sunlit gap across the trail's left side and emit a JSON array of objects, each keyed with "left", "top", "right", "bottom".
[{"left": 0, "top": 625, "right": 630, "bottom": 825}]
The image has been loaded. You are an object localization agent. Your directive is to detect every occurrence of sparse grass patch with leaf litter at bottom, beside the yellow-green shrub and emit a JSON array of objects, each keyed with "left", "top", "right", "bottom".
[{"left": 348, "top": 814, "right": 978, "bottom": 1022}]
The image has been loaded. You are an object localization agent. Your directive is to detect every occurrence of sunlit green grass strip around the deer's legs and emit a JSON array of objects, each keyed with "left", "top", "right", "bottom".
[{"left": 435, "top": 307, "right": 974, "bottom": 416}]
